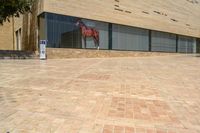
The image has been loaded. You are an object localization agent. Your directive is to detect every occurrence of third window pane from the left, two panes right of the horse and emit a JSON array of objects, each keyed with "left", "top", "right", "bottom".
[{"left": 151, "top": 31, "right": 176, "bottom": 52}]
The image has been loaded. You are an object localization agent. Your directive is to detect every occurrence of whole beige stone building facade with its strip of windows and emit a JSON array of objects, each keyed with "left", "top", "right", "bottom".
[{"left": 0, "top": 0, "right": 200, "bottom": 53}]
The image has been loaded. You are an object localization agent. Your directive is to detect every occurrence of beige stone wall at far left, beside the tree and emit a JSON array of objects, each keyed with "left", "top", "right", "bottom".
[{"left": 0, "top": 0, "right": 43, "bottom": 51}]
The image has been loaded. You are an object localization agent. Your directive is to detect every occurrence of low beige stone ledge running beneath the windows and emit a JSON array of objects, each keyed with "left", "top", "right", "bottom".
[{"left": 47, "top": 48, "right": 177, "bottom": 59}]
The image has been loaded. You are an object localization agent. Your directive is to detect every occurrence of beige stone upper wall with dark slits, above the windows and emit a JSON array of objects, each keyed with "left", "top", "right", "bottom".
[{"left": 43, "top": 0, "right": 200, "bottom": 37}]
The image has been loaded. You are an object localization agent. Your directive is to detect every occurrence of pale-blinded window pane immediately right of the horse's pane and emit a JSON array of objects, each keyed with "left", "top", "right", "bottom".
[{"left": 112, "top": 24, "right": 149, "bottom": 51}]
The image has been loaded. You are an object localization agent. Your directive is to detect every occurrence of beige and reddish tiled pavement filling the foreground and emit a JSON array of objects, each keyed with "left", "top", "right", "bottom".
[{"left": 0, "top": 55, "right": 200, "bottom": 133}]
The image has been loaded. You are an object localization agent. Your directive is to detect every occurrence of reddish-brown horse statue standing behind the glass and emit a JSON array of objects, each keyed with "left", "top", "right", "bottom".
[{"left": 76, "top": 20, "right": 99, "bottom": 50}]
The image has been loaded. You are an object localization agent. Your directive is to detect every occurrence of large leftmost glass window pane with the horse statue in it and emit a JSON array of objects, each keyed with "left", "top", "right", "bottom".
[{"left": 40, "top": 13, "right": 108, "bottom": 49}]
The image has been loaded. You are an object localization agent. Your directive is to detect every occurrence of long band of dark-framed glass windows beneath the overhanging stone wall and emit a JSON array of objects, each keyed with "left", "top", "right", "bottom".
[{"left": 38, "top": 13, "right": 199, "bottom": 53}]
